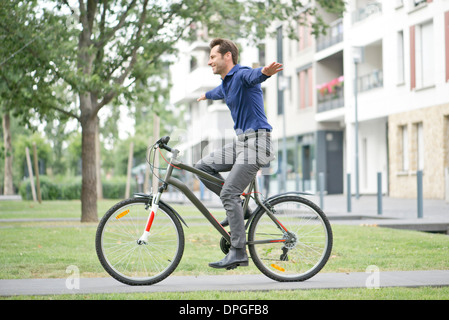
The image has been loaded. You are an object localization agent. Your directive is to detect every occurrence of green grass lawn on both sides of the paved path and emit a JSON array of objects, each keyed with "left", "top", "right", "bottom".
[{"left": 0, "top": 200, "right": 449, "bottom": 299}]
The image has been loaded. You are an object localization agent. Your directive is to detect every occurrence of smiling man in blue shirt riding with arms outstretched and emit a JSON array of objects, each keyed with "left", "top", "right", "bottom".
[{"left": 195, "top": 38, "right": 282, "bottom": 269}]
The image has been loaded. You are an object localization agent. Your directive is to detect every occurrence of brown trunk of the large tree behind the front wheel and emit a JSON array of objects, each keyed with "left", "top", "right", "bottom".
[{"left": 80, "top": 99, "right": 98, "bottom": 222}]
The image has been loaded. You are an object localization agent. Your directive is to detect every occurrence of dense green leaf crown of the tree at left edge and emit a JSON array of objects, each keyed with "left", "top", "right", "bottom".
[{"left": 0, "top": 0, "right": 75, "bottom": 126}]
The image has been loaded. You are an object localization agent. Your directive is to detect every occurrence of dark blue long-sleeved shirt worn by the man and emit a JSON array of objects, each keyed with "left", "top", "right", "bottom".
[{"left": 206, "top": 64, "right": 272, "bottom": 134}]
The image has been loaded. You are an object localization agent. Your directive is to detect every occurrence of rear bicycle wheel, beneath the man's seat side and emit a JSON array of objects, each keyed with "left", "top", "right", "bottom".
[{"left": 248, "top": 196, "right": 333, "bottom": 281}]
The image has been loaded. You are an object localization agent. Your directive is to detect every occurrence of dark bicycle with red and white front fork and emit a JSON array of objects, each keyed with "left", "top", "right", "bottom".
[{"left": 95, "top": 137, "right": 333, "bottom": 285}]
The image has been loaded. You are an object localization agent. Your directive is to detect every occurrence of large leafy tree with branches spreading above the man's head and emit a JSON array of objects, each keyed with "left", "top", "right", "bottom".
[{"left": 2, "top": 0, "right": 343, "bottom": 222}]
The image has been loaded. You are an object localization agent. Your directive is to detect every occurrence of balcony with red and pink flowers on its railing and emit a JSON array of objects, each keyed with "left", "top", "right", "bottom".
[{"left": 317, "top": 76, "right": 345, "bottom": 112}]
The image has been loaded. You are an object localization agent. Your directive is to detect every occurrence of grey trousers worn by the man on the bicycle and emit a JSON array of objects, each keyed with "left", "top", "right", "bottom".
[{"left": 195, "top": 132, "right": 274, "bottom": 248}]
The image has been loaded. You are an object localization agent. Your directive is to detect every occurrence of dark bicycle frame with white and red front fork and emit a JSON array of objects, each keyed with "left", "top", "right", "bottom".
[{"left": 138, "top": 149, "right": 288, "bottom": 244}]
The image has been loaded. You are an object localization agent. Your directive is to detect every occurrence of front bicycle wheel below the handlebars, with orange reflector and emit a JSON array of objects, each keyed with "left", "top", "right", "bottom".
[{"left": 95, "top": 198, "right": 184, "bottom": 285}]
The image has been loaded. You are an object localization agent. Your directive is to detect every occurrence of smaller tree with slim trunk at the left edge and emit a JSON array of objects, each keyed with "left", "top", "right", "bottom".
[{"left": 0, "top": 1, "right": 69, "bottom": 194}]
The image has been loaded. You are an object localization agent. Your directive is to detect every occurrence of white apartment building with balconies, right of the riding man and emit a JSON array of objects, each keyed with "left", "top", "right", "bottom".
[{"left": 266, "top": 0, "right": 449, "bottom": 199}]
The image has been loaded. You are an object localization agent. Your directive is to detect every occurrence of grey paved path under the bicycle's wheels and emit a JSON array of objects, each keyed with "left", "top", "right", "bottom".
[{"left": 0, "top": 270, "right": 449, "bottom": 296}]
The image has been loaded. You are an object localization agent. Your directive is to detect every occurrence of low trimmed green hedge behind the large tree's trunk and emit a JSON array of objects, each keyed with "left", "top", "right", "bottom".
[{"left": 19, "top": 176, "right": 137, "bottom": 200}]
